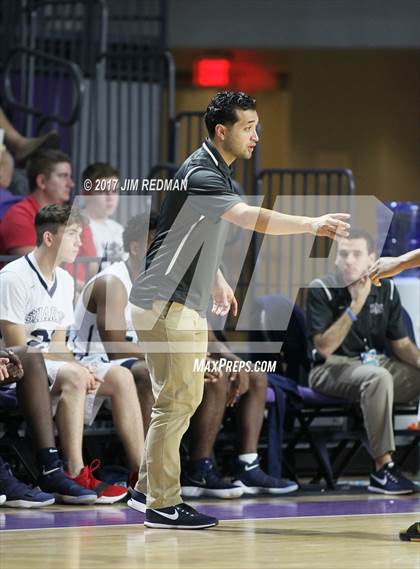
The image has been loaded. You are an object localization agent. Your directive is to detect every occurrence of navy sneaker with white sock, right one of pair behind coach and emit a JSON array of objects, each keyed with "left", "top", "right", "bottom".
[{"left": 233, "top": 458, "right": 298, "bottom": 494}]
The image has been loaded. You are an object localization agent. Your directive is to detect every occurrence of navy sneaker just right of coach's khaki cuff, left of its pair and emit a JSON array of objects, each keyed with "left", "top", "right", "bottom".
[{"left": 181, "top": 458, "right": 244, "bottom": 498}]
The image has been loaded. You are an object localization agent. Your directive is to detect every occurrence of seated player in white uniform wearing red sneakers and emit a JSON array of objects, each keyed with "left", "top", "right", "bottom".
[{"left": 0, "top": 205, "right": 144, "bottom": 503}]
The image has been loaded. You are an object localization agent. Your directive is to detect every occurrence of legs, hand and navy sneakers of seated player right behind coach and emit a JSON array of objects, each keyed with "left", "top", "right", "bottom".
[{"left": 181, "top": 330, "right": 298, "bottom": 498}]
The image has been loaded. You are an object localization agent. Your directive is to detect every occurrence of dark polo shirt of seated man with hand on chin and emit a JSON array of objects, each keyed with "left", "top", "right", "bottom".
[{"left": 307, "top": 274, "right": 408, "bottom": 357}]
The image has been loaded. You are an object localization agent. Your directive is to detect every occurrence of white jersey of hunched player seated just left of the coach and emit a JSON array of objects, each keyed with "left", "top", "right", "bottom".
[{"left": 70, "top": 261, "right": 137, "bottom": 362}]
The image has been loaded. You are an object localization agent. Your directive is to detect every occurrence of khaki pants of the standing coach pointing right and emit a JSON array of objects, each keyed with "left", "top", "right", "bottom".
[{"left": 131, "top": 301, "right": 208, "bottom": 508}]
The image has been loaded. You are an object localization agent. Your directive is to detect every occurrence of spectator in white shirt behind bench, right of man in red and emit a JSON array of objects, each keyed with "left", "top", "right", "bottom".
[{"left": 82, "top": 162, "right": 124, "bottom": 262}]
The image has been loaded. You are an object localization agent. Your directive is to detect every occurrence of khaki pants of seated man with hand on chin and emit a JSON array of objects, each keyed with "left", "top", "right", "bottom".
[{"left": 309, "top": 355, "right": 420, "bottom": 458}]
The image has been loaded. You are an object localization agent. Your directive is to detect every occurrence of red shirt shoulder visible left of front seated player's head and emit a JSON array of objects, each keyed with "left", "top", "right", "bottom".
[{"left": 1, "top": 196, "right": 41, "bottom": 253}]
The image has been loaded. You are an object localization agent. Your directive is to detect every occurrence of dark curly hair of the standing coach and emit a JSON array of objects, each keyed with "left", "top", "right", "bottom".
[{"left": 204, "top": 91, "right": 257, "bottom": 138}]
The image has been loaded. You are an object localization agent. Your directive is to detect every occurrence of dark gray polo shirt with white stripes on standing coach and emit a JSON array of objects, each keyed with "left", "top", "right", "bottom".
[{"left": 130, "top": 140, "right": 242, "bottom": 316}]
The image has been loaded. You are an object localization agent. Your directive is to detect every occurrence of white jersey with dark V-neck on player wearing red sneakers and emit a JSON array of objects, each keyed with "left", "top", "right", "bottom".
[{"left": 0, "top": 252, "right": 74, "bottom": 352}]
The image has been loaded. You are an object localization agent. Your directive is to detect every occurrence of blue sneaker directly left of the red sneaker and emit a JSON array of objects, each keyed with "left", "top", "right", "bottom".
[{"left": 38, "top": 463, "right": 98, "bottom": 505}]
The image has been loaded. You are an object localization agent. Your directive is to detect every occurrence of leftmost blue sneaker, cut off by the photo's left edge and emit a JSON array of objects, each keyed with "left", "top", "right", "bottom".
[{"left": 0, "top": 462, "right": 55, "bottom": 508}]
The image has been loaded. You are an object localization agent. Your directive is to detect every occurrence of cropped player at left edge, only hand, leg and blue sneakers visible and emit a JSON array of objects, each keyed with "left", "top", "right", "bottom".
[{"left": 0, "top": 347, "right": 97, "bottom": 508}]
